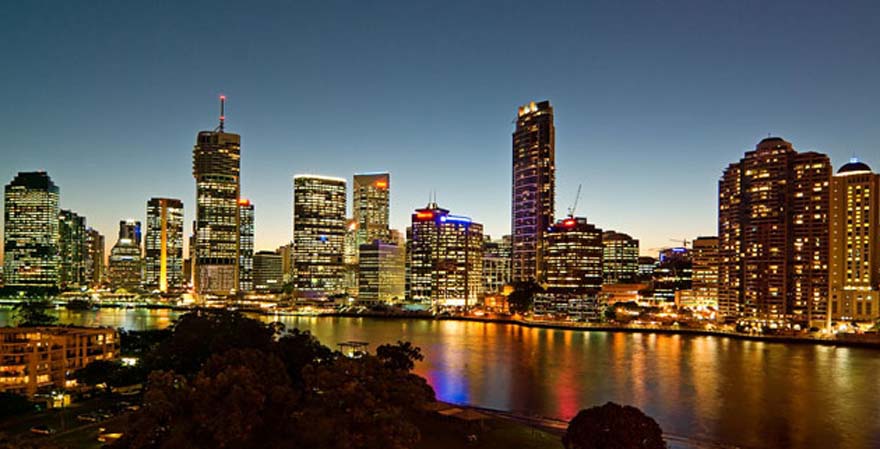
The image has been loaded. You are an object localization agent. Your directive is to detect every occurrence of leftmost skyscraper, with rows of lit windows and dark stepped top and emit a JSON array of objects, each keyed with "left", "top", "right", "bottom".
[{"left": 3, "top": 172, "right": 60, "bottom": 288}]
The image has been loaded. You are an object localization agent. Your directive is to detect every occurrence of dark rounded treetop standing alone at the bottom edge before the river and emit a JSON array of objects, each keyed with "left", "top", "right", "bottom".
[{"left": 562, "top": 402, "right": 666, "bottom": 449}]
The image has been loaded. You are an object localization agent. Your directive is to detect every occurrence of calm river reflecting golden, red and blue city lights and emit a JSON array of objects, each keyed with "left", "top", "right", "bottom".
[{"left": 0, "top": 309, "right": 880, "bottom": 448}]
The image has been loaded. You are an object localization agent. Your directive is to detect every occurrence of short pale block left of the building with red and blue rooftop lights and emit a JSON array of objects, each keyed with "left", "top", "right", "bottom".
[{"left": 357, "top": 239, "right": 406, "bottom": 303}]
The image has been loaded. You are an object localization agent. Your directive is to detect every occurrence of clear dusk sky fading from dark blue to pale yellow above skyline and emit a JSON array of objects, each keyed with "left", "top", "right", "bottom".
[{"left": 0, "top": 0, "right": 880, "bottom": 253}]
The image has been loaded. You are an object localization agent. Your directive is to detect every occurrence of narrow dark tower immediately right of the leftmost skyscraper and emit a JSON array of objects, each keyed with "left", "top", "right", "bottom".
[{"left": 58, "top": 209, "right": 88, "bottom": 289}]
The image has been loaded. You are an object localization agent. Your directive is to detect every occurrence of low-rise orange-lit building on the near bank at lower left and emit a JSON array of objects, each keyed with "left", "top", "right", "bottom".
[{"left": 0, "top": 326, "right": 119, "bottom": 396}]
